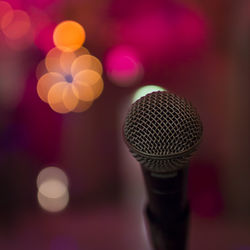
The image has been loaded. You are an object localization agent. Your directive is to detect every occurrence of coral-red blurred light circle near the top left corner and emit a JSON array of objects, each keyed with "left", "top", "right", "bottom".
[{"left": 1, "top": 10, "right": 31, "bottom": 40}]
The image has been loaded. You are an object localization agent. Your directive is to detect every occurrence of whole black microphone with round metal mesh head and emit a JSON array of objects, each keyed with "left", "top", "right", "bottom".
[{"left": 123, "top": 91, "right": 203, "bottom": 250}]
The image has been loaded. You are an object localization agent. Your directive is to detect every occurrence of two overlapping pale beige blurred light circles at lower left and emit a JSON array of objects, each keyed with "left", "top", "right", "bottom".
[{"left": 37, "top": 167, "right": 69, "bottom": 212}]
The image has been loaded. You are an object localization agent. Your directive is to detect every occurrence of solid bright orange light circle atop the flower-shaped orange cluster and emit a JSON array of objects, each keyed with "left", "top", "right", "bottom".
[{"left": 53, "top": 21, "right": 86, "bottom": 52}]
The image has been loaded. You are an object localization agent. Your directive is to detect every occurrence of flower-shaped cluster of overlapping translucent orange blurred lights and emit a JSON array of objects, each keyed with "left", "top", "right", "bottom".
[{"left": 36, "top": 47, "right": 104, "bottom": 114}]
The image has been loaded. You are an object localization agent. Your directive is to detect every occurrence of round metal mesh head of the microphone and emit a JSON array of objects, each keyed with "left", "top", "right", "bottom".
[{"left": 123, "top": 91, "right": 202, "bottom": 172}]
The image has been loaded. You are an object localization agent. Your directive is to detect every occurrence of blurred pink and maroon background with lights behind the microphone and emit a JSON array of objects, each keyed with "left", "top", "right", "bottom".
[{"left": 0, "top": 0, "right": 250, "bottom": 250}]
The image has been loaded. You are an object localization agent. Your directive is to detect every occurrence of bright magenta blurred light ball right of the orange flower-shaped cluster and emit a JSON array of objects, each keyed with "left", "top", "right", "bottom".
[{"left": 106, "top": 46, "right": 143, "bottom": 87}]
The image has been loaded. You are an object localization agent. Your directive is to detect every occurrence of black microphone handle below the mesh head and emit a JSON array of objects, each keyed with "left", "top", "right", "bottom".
[{"left": 142, "top": 166, "right": 189, "bottom": 250}]
